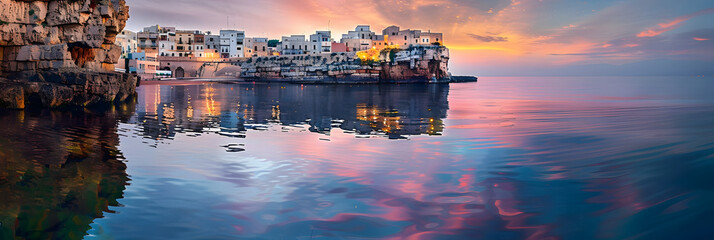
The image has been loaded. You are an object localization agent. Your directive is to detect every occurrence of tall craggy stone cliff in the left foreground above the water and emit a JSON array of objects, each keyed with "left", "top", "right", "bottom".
[{"left": 0, "top": 0, "right": 136, "bottom": 108}]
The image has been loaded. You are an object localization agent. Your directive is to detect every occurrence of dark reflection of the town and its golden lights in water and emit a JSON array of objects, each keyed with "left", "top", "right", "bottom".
[{"left": 131, "top": 84, "right": 449, "bottom": 139}]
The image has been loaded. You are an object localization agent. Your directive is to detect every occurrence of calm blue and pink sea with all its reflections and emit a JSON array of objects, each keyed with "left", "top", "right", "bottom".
[{"left": 0, "top": 77, "right": 714, "bottom": 239}]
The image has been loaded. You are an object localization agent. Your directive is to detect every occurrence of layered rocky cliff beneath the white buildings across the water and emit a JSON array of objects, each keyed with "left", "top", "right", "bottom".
[{"left": 199, "top": 46, "right": 475, "bottom": 83}]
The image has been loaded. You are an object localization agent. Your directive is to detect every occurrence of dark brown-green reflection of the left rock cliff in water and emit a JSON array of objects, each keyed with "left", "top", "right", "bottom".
[{"left": 0, "top": 104, "right": 134, "bottom": 239}]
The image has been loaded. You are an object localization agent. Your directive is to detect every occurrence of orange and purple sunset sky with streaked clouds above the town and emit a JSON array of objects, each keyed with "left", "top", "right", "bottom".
[{"left": 127, "top": 0, "right": 714, "bottom": 76}]
